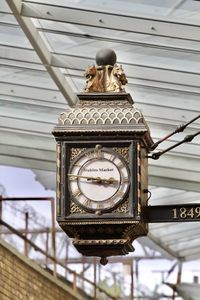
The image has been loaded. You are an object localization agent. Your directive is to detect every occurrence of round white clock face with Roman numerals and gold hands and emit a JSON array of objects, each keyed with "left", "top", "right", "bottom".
[{"left": 68, "top": 145, "right": 130, "bottom": 212}]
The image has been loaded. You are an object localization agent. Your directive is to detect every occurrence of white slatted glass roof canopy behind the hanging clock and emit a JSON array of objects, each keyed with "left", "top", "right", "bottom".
[{"left": 0, "top": 0, "right": 200, "bottom": 292}]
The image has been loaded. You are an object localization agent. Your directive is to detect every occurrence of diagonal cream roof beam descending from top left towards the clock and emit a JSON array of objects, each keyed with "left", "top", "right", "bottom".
[{"left": 6, "top": 0, "right": 77, "bottom": 105}]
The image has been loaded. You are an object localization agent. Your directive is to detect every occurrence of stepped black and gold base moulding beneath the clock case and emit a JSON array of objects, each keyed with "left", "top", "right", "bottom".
[{"left": 60, "top": 221, "right": 148, "bottom": 258}]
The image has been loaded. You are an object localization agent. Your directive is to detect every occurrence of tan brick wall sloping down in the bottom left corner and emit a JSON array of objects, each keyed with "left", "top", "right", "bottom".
[{"left": 0, "top": 238, "right": 86, "bottom": 300}]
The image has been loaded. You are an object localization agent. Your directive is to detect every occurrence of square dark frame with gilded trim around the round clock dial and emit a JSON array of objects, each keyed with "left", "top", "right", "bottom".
[{"left": 61, "top": 140, "right": 138, "bottom": 220}]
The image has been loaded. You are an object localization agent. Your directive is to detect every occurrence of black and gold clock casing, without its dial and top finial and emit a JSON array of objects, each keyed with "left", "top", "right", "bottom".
[{"left": 53, "top": 93, "right": 153, "bottom": 262}]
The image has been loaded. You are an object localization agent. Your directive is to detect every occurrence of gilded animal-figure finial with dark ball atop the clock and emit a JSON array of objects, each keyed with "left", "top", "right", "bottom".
[{"left": 84, "top": 48, "right": 128, "bottom": 93}]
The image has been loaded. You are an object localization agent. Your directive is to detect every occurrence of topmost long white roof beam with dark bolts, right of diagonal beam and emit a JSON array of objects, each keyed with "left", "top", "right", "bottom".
[{"left": 20, "top": 0, "right": 199, "bottom": 41}]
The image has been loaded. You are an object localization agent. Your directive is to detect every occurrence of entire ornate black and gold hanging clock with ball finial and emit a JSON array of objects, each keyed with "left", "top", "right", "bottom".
[{"left": 53, "top": 49, "right": 153, "bottom": 263}]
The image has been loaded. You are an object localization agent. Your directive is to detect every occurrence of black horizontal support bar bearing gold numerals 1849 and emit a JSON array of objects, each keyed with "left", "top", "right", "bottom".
[{"left": 142, "top": 203, "right": 200, "bottom": 223}]
